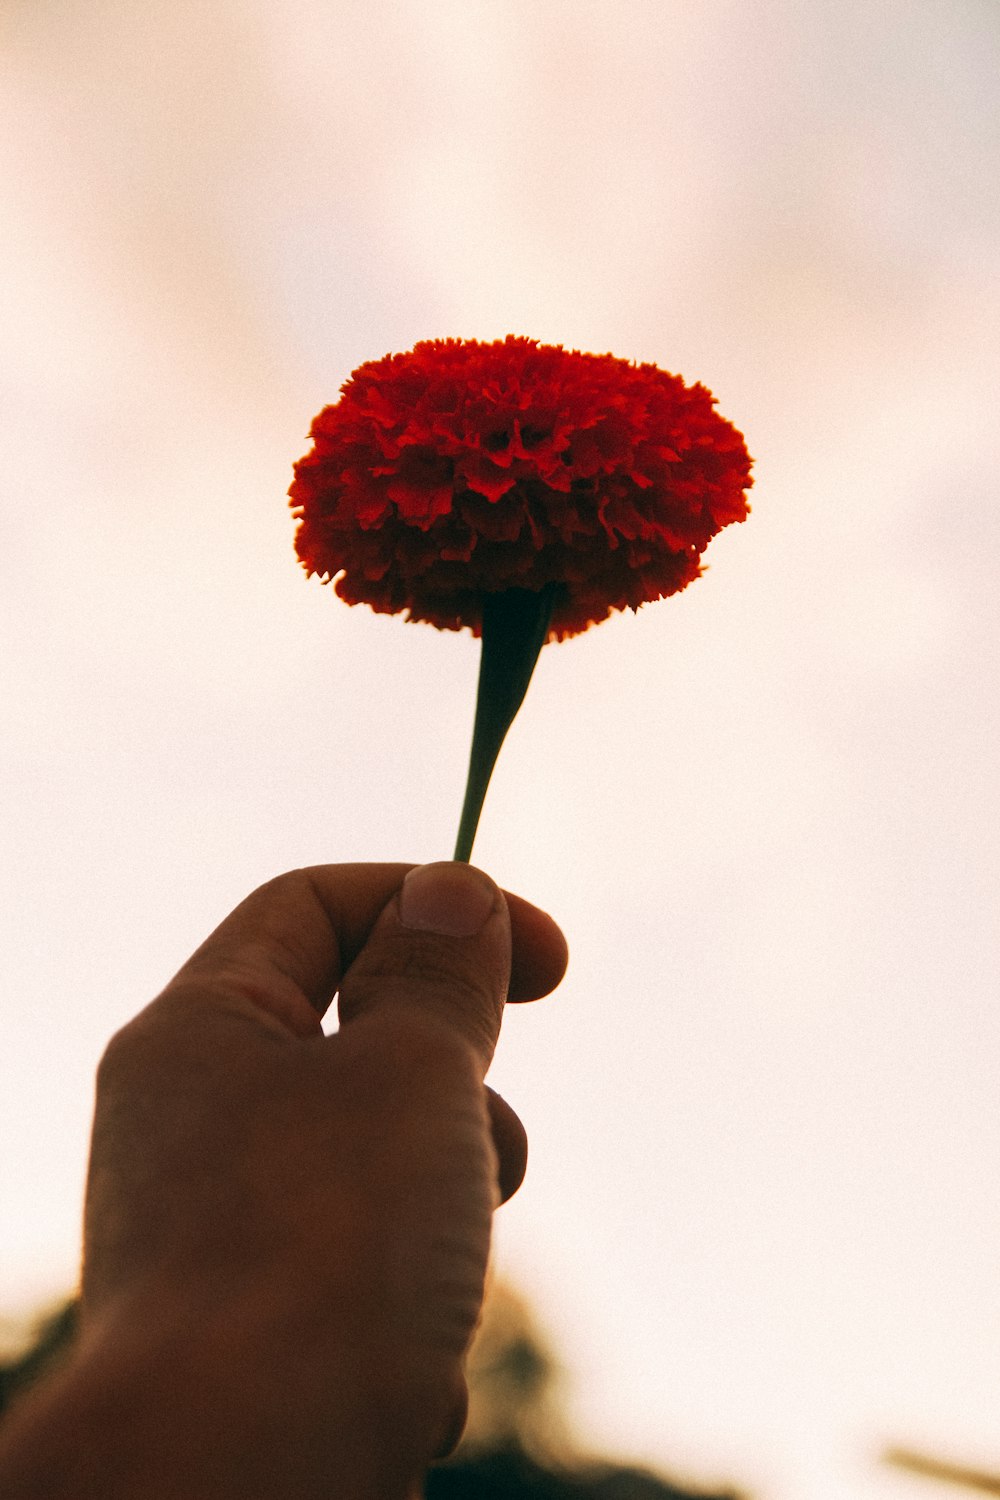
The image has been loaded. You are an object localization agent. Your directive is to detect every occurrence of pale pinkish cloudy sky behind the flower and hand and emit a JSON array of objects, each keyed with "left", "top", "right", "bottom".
[{"left": 0, "top": 0, "right": 1000, "bottom": 1500}]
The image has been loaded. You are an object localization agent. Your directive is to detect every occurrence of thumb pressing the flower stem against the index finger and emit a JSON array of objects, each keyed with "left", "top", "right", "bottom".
[{"left": 340, "top": 861, "right": 511, "bottom": 1073}]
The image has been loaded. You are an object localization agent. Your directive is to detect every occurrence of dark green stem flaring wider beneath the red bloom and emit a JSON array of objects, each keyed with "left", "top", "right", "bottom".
[{"left": 453, "top": 584, "right": 556, "bottom": 864}]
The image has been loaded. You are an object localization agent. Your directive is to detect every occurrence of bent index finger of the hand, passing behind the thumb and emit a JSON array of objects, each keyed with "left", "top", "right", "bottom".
[{"left": 168, "top": 864, "right": 567, "bottom": 1035}]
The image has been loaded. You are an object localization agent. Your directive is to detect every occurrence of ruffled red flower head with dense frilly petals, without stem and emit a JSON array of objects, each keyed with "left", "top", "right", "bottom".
[{"left": 289, "top": 336, "right": 753, "bottom": 639}]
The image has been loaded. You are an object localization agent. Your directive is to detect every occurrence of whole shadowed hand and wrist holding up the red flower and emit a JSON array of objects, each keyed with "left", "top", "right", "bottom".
[{"left": 0, "top": 864, "right": 567, "bottom": 1500}]
